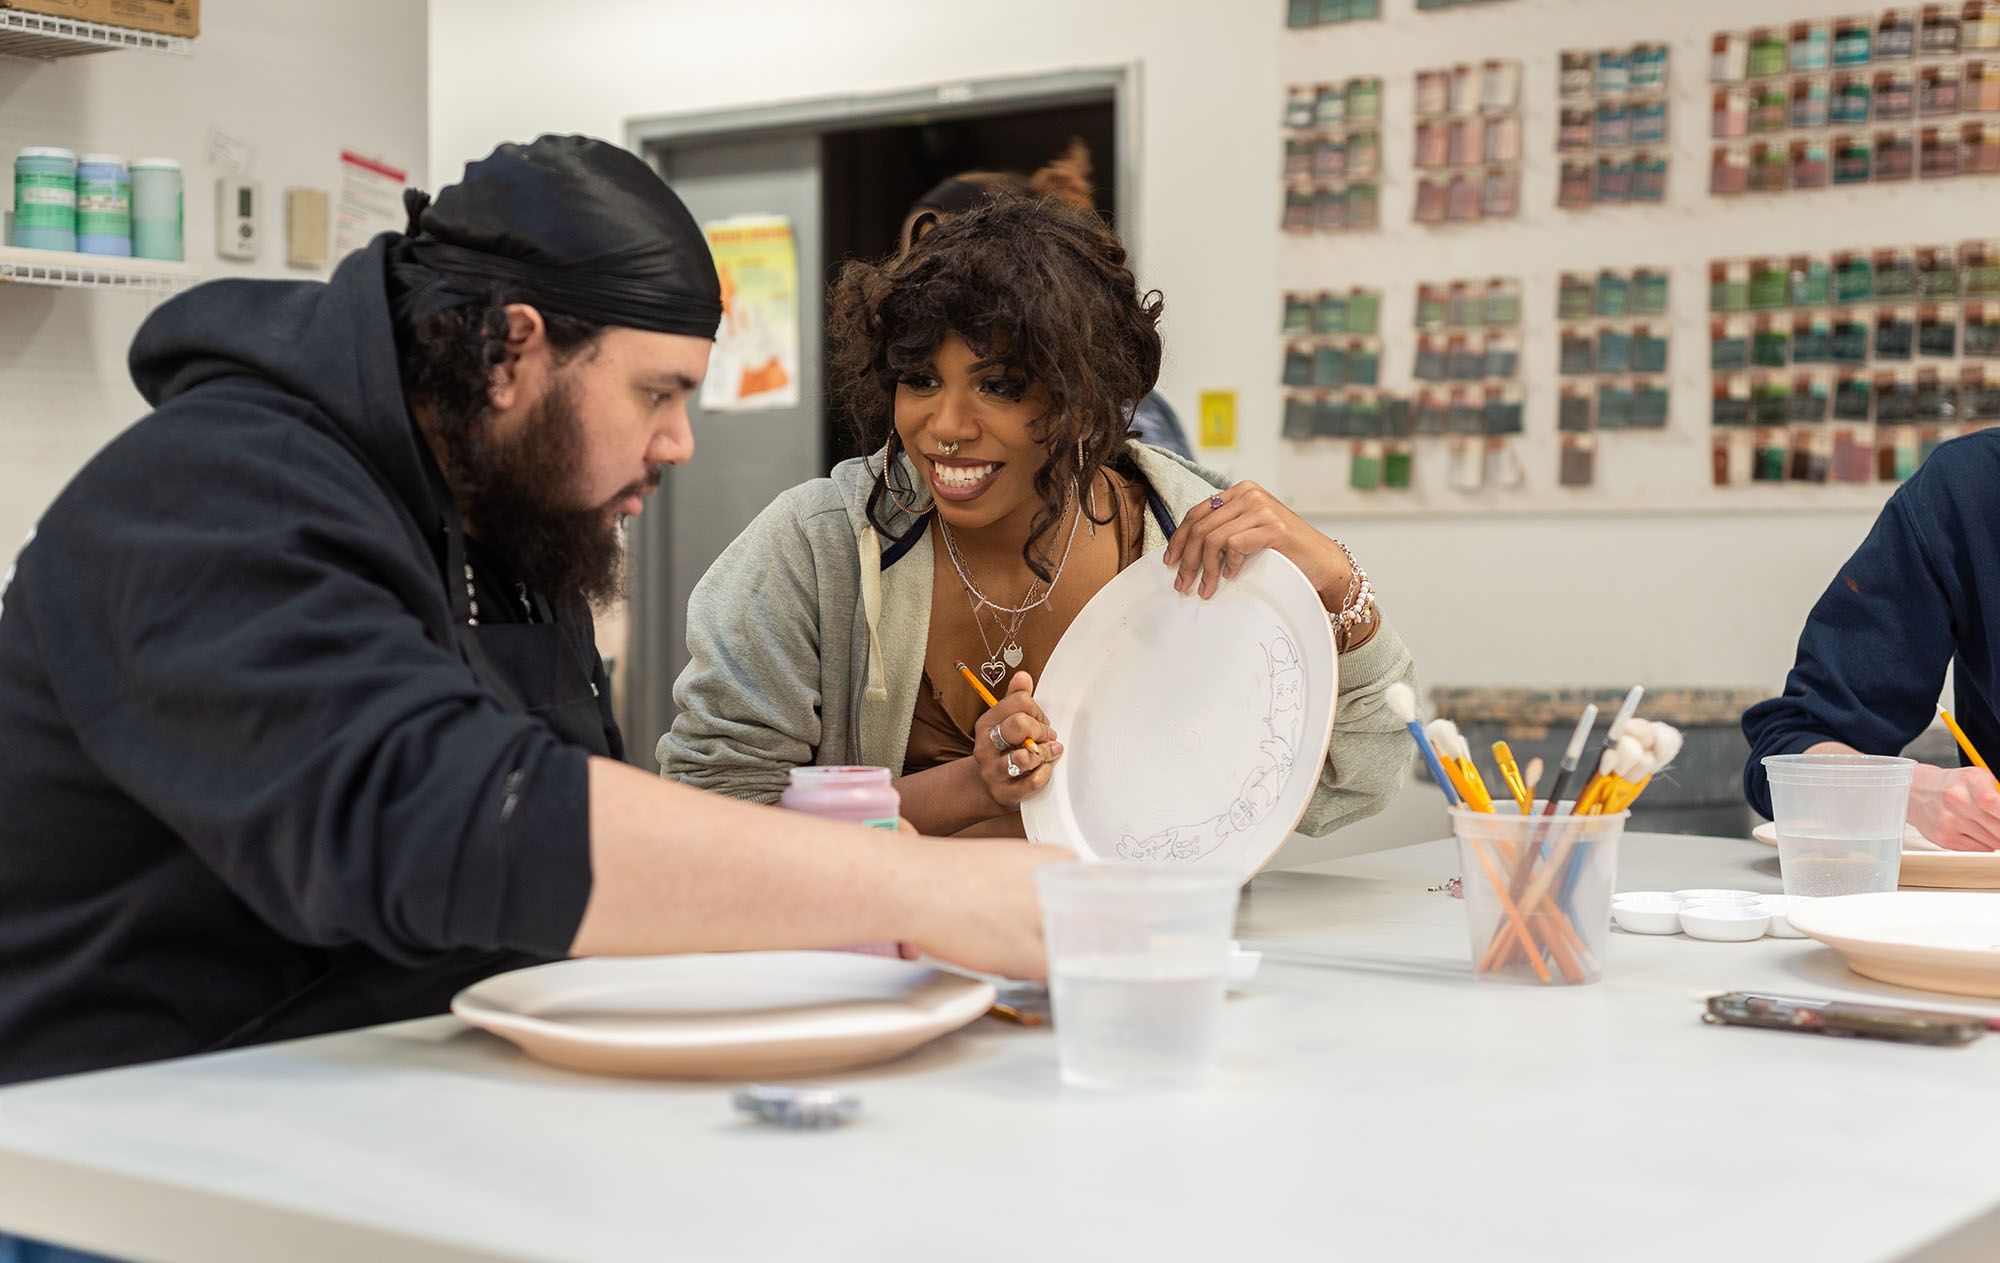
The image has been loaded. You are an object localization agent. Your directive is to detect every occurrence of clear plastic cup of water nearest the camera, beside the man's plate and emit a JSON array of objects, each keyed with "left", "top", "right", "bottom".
[{"left": 1034, "top": 863, "right": 1242, "bottom": 1089}]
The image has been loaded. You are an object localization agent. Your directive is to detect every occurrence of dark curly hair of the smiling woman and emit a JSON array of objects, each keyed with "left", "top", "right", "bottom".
[{"left": 828, "top": 194, "right": 1164, "bottom": 582}]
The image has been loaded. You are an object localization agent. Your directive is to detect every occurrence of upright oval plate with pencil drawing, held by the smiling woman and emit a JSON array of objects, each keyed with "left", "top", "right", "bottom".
[{"left": 1022, "top": 550, "right": 1340, "bottom": 877}]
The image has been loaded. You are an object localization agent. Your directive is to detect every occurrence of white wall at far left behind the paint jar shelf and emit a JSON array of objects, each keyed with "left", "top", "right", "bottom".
[{"left": 0, "top": 0, "right": 428, "bottom": 551}]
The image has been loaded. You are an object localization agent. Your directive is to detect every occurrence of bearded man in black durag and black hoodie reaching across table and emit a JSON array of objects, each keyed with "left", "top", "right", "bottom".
[{"left": 0, "top": 136, "right": 1066, "bottom": 1081}]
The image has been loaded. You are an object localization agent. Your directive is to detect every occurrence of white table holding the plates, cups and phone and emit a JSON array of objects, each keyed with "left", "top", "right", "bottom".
[{"left": 0, "top": 835, "right": 2000, "bottom": 1263}]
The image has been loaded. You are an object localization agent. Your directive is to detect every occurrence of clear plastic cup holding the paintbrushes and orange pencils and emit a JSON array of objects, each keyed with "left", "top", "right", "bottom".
[{"left": 1452, "top": 803, "right": 1626, "bottom": 985}]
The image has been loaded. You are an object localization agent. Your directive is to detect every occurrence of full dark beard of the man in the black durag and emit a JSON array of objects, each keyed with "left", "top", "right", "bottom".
[{"left": 438, "top": 376, "right": 648, "bottom": 608}]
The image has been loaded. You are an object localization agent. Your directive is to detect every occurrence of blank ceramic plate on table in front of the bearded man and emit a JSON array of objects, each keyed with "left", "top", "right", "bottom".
[{"left": 452, "top": 951, "right": 994, "bottom": 1079}]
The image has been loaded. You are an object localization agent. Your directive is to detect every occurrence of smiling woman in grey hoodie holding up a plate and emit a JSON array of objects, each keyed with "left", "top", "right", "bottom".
[{"left": 658, "top": 196, "right": 1414, "bottom": 835}]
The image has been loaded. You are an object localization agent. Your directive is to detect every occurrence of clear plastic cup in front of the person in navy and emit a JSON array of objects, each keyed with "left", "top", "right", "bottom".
[{"left": 1764, "top": 753, "right": 1916, "bottom": 895}]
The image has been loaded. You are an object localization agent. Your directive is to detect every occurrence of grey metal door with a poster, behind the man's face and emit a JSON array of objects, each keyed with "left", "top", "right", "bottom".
[{"left": 618, "top": 136, "right": 826, "bottom": 769}]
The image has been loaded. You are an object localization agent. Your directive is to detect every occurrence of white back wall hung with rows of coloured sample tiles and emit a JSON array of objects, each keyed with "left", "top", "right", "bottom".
[{"left": 430, "top": 0, "right": 1936, "bottom": 857}]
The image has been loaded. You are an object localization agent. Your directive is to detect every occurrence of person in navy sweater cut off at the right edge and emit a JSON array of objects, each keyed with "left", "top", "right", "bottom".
[{"left": 1744, "top": 430, "right": 2000, "bottom": 851}]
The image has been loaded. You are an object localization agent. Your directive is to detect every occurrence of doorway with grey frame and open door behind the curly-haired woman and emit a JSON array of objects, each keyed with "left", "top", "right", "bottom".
[{"left": 608, "top": 66, "right": 1136, "bottom": 769}]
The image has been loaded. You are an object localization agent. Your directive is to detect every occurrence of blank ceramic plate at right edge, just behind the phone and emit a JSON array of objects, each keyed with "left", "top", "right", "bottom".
[{"left": 1788, "top": 891, "right": 2000, "bottom": 995}]
